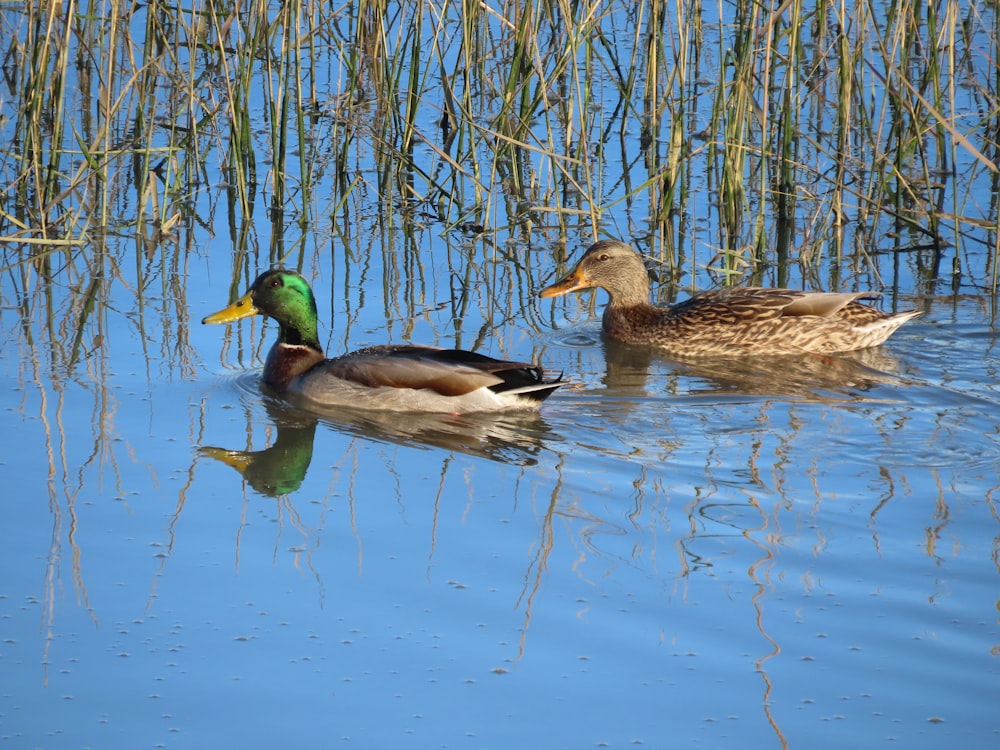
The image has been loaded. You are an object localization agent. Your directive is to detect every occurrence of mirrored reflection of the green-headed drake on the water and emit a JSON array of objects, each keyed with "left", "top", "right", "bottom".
[{"left": 199, "top": 394, "right": 551, "bottom": 497}]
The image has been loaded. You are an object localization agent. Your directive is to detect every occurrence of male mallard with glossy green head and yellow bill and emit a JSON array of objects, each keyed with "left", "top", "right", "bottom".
[{"left": 202, "top": 268, "right": 561, "bottom": 414}]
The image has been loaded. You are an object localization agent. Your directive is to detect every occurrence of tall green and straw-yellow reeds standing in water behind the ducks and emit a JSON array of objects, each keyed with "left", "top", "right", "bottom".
[{"left": 0, "top": 0, "right": 1000, "bottom": 294}]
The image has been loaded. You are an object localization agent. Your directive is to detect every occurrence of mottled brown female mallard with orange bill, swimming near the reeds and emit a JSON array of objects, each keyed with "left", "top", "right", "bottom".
[{"left": 541, "top": 240, "right": 920, "bottom": 356}]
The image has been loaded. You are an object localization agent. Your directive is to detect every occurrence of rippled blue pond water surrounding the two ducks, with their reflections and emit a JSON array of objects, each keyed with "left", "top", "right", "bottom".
[{"left": 0, "top": 1, "right": 1000, "bottom": 748}]
